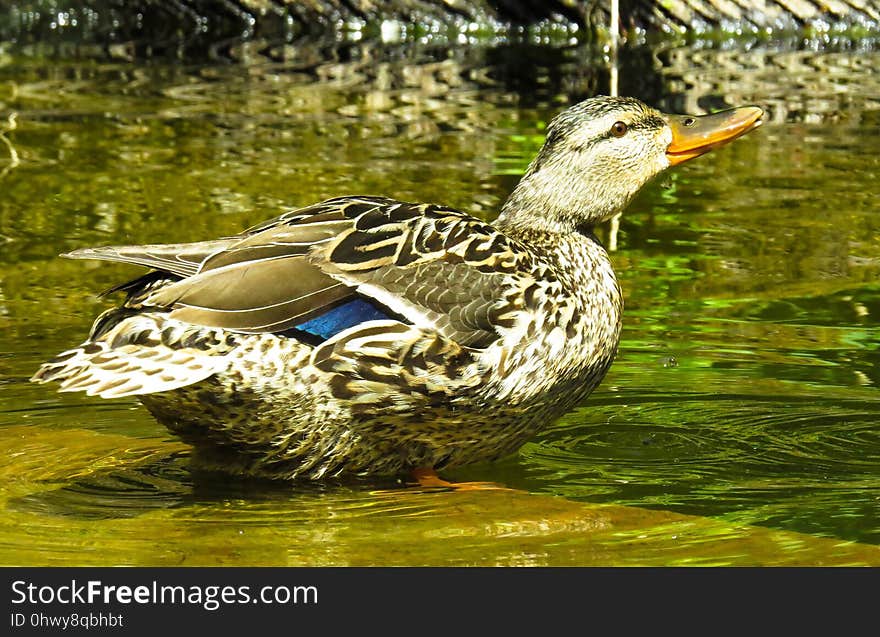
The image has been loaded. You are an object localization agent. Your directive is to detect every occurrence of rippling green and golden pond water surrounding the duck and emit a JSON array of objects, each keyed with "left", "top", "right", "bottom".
[{"left": 0, "top": 42, "right": 880, "bottom": 565}]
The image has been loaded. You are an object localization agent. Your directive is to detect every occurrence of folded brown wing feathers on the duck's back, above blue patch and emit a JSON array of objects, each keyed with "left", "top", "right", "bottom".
[{"left": 70, "top": 197, "right": 530, "bottom": 347}]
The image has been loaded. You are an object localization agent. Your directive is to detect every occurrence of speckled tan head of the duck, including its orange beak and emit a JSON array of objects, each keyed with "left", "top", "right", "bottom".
[{"left": 496, "top": 96, "right": 764, "bottom": 237}]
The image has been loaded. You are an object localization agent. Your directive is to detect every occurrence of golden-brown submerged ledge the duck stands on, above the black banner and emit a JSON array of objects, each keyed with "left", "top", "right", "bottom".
[{"left": 0, "top": 426, "right": 880, "bottom": 566}]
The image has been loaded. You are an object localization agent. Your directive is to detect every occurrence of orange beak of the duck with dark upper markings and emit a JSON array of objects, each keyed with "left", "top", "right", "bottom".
[{"left": 663, "top": 106, "right": 764, "bottom": 166}]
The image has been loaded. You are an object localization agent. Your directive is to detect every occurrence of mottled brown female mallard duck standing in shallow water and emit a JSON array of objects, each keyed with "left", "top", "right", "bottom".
[{"left": 32, "top": 97, "right": 763, "bottom": 479}]
